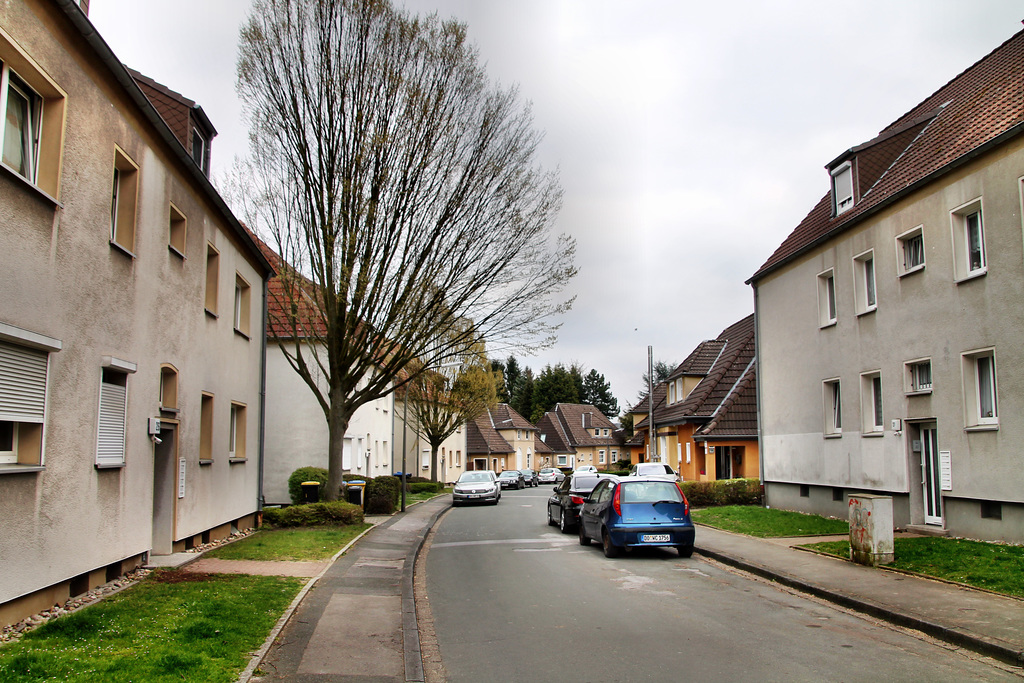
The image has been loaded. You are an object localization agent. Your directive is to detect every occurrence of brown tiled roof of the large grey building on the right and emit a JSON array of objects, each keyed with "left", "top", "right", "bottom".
[{"left": 749, "top": 31, "right": 1024, "bottom": 282}]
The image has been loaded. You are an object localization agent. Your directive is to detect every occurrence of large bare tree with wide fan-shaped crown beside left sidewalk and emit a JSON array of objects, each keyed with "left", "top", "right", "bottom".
[{"left": 238, "top": 0, "right": 575, "bottom": 498}]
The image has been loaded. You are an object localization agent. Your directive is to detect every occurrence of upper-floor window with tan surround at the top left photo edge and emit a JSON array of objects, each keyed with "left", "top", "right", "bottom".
[{"left": 0, "top": 29, "right": 67, "bottom": 198}]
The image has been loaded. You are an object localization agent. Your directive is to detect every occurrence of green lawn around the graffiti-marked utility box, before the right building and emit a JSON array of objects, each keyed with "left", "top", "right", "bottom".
[{"left": 806, "top": 538, "right": 1024, "bottom": 597}]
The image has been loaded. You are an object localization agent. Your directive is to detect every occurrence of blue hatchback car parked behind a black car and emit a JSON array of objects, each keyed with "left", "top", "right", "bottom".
[{"left": 580, "top": 477, "right": 694, "bottom": 557}]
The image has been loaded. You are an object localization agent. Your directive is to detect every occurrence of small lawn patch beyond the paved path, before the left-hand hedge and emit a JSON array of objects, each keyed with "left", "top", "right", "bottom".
[{"left": 204, "top": 524, "right": 371, "bottom": 562}]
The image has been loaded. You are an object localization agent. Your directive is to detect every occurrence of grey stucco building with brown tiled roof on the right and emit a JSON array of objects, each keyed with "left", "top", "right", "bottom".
[{"left": 750, "top": 29, "right": 1024, "bottom": 542}]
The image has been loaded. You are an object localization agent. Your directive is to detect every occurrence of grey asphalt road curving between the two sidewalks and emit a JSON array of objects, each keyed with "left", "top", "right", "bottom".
[{"left": 425, "top": 485, "right": 1021, "bottom": 683}]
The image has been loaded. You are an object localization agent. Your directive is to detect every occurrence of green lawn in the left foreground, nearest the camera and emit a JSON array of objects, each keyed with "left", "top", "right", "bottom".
[{"left": 0, "top": 570, "right": 305, "bottom": 683}]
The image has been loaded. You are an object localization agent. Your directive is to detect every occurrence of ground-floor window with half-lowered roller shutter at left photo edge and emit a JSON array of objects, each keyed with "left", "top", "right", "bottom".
[{"left": 0, "top": 324, "right": 61, "bottom": 467}]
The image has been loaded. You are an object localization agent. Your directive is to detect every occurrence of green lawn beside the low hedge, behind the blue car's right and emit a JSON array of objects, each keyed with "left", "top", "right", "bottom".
[{"left": 690, "top": 505, "right": 850, "bottom": 539}]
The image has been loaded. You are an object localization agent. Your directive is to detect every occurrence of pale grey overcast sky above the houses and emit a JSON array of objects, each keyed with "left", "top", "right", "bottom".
[{"left": 89, "top": 0, "right": 1024, "bottom": 408}]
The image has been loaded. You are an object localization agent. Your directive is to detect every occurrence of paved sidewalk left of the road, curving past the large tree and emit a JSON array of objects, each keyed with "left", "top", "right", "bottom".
[{"left": 240, "top": 496, "right": 452, "bottom": 683}]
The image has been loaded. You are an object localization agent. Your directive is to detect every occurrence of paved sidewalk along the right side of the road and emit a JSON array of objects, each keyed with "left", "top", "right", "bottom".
[{"left": 695, "top": 526, "right": 1024, "bottom": 667}]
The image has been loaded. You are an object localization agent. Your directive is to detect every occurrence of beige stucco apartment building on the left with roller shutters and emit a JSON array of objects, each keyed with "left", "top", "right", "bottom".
[{"left": 0, "top": 0, "right": 271, "bottom": 623}]
